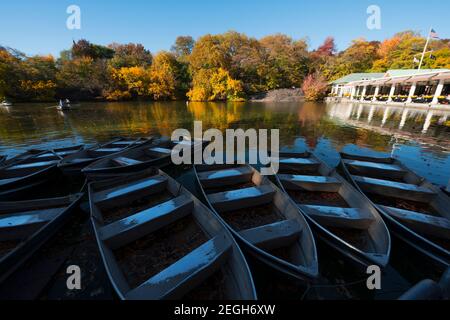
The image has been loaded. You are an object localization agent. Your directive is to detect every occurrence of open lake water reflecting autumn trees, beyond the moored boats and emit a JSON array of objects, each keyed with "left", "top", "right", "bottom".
[{"left": 0, "top": 102, "right": 450, "bottom": 185}]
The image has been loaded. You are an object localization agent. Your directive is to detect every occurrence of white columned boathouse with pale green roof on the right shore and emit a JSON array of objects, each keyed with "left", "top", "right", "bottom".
[{"left": 330, "top": 69, "right": 450, "bottom": 106}]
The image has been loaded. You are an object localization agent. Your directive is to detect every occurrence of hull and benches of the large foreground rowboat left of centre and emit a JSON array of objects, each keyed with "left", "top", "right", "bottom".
[{"left": 89, "top": 168, "right": 256, "bottom": 300}]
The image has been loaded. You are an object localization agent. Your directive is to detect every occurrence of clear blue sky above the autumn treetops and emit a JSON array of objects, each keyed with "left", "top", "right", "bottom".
[{"left": 0, "top": 0, "right": 450, "bottom": 55}]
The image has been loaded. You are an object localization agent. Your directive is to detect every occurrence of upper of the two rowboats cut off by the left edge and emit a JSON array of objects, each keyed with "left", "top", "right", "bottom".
[{"left": 0, "top": 151, "right": 61, "bottom": 201}]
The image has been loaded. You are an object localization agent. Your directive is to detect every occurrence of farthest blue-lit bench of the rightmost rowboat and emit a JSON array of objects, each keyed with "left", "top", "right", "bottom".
[{"left": 344, "top": 160, "right": 407, "bottom": 179}]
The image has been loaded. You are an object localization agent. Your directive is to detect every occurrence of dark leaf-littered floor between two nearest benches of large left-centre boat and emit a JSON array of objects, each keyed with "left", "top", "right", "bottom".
[{"left": 114, "top": 216, "right": 208, "bottom": 288}]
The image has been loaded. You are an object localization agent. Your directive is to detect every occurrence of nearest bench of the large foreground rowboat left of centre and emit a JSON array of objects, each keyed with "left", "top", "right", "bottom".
[{"left": 126, "top": 234, "right": 232, "bottom": 300}]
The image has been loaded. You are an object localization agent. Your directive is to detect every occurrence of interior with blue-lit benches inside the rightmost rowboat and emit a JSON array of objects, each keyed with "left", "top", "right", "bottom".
[{"left": 342, "top": 153, "right": 450, "bottom": 250}]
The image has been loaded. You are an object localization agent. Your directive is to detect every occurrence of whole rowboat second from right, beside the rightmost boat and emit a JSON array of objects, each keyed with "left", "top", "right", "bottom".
[{"left": 276, "top": 152, "right": 391, "bottom": 267}]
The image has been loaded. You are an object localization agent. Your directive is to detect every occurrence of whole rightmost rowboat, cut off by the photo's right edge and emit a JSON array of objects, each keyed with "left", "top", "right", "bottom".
[{"left": 341, "top": 153, "right": 450, "bottom": 268}]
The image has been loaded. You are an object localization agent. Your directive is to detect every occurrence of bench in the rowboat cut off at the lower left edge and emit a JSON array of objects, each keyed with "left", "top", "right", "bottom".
[{"left": 0, "top": 207, "right": 65, "bottom": 241}]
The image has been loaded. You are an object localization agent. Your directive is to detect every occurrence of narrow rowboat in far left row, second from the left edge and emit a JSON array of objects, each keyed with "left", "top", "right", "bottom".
[{"left": 58, "top": 138, "right": 153, "bottom": 176}]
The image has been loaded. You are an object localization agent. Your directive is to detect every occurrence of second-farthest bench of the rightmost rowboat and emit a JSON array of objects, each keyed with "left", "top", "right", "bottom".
[{"left": 353, "top": 176, "right": 436, "bottom": 202}]
